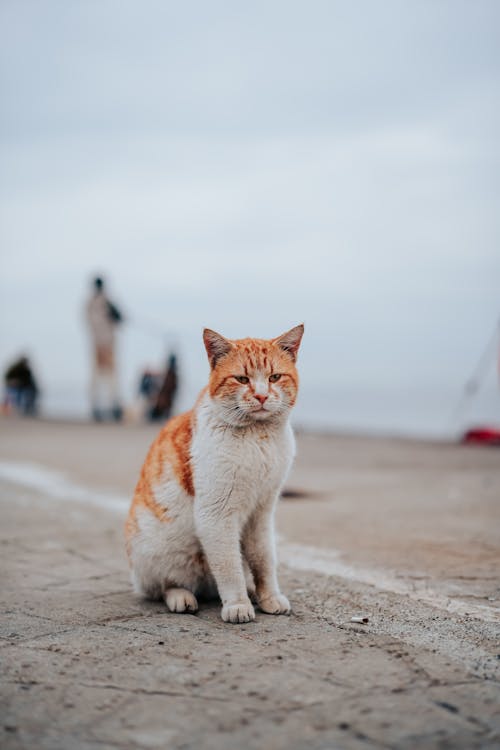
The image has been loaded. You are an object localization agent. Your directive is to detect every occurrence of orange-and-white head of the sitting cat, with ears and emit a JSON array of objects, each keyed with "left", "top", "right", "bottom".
[{"left": 203, "top": 325, "right": 304, "bottom": 426}]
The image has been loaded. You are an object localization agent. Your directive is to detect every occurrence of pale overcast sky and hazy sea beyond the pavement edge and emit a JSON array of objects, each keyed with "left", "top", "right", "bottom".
[{"left": 0, "top": 0, "right": 500, "bottom": 437}]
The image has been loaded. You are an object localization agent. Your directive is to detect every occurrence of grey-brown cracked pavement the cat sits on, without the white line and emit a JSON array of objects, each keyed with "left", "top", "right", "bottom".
[{"left": 0, "top": 422, "right": 500, "bottom": 750}]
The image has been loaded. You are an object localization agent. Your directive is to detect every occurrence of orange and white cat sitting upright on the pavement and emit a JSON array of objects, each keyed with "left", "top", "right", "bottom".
[{"left": 126, "top": 325, "right": 304, "bottom": 622}]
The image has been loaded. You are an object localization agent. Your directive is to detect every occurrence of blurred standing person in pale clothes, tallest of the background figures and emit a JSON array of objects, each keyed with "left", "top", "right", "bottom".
[{"left": 86, "top": 276, "right": 123, "bottom": 422}]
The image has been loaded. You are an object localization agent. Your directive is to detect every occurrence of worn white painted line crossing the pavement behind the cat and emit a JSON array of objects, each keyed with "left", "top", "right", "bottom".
[{"left": 0, "top": 461, "right": 500, "bottom": 622}]
